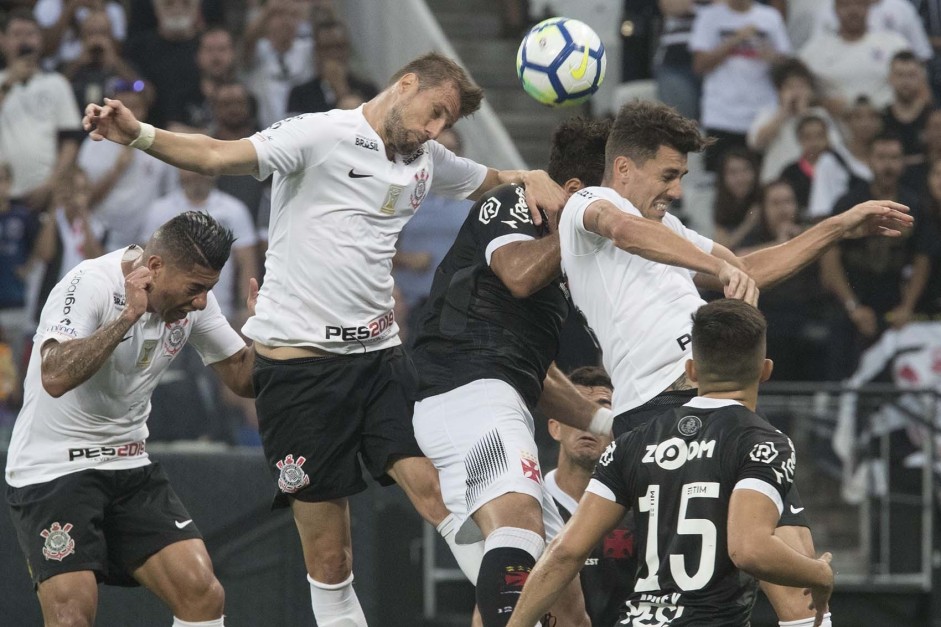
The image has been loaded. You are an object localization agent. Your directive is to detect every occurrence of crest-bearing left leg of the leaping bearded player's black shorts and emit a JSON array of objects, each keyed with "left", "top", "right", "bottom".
[{"left": 252, "top": 354, "right": 374, "bottom": 507}]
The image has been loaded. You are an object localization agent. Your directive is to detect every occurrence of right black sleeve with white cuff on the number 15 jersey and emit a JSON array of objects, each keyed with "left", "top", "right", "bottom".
[{"left": 735, "top": 423, "right": 797, "bottom": 511}]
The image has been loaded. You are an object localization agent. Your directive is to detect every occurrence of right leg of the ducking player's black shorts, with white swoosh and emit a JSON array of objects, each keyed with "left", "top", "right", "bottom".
[{"left": 102, "top": 462, "right": 203, "bottom": 585}]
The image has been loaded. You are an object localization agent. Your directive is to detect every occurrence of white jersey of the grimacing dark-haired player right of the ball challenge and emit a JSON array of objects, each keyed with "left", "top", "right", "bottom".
[{"left": 559, "top": 187, "right": 713, "bottom": 414}]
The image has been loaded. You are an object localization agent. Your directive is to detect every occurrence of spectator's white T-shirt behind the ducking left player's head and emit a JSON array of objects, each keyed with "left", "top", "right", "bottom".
[{"left": 141, "top": 189, "right": 258, "bottom": 318}]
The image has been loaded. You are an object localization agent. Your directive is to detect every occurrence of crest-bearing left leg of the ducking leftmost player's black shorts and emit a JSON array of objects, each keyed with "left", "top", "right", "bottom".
[{"left": 7, "top": 470, "right": 113, "bottom": 585}]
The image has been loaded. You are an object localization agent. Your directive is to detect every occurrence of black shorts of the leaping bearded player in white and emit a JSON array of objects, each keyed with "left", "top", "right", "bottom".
[{"left": 252, "top": 347, "right": 422, "bottom": 507}]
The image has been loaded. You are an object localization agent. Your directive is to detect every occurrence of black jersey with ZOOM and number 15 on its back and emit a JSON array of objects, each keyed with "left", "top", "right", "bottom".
[{"left": 588, "top": 397, "right": 796, "bottom": 627}]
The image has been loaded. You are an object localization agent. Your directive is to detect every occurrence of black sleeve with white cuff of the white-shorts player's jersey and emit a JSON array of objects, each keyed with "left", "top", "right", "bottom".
[{"left": 473, "top": 184, "right": 541, "bottom": 266}]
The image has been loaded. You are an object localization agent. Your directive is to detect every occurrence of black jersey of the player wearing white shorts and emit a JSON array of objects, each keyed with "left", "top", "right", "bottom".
[{"left": 412, "top": 185, "right": 569, "bottom": 407}]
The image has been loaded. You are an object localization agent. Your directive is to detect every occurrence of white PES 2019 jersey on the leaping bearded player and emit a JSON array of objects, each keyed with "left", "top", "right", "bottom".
[{"left": 243, "top": 107, "right": 487, "bottom": 354}]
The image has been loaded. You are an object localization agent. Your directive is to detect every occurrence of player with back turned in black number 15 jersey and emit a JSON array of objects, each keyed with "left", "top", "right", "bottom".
[{"left": 508, "top": 300, "right": 833, "bottom": 627}]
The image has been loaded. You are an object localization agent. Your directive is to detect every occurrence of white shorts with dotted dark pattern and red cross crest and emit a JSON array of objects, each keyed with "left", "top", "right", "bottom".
[{"left": 412, "top": 379, "right": 562, "bottom": 544}]
